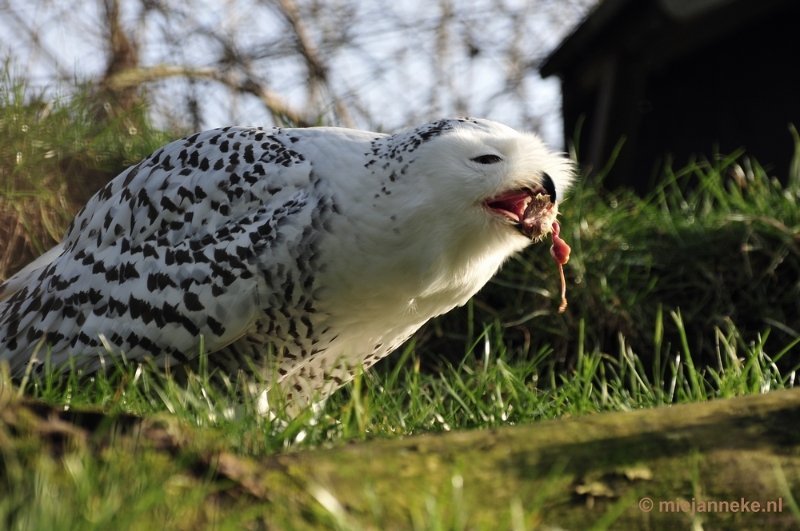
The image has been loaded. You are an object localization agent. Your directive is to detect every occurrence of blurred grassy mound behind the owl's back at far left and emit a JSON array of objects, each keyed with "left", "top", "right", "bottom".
[{"left": 0, "top": 62, "right": 177, "bottom": 279}]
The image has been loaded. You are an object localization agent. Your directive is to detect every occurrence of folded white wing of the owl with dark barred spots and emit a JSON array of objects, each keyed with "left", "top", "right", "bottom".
[{"left": 0, "top": 128, "right": 335, "bottom": 374}]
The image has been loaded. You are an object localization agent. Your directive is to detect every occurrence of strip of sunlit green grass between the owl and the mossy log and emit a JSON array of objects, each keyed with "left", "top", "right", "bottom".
[{"left": 7, "top": 304, "right": 800, "bottom": 455}]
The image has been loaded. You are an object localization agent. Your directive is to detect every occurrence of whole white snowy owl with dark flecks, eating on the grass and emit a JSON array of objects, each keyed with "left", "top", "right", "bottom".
[{"left": 0, "top": 118, "right": 573, "bottom": 406}]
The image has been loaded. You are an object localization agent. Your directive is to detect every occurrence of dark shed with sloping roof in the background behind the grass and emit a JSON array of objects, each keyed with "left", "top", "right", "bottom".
[{"left": 541, "top": 0, "right": 800, "bottom": 192}]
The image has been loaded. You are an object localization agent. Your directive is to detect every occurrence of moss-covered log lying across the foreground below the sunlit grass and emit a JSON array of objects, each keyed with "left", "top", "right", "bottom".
[{"left": 0, "top": 389, "right": 800, "bottom": 531}]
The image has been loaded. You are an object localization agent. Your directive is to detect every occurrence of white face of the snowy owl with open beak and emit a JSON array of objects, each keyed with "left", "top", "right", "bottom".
[{"left": 418, "top": 120, "right": 574, "bottom": 248}]
